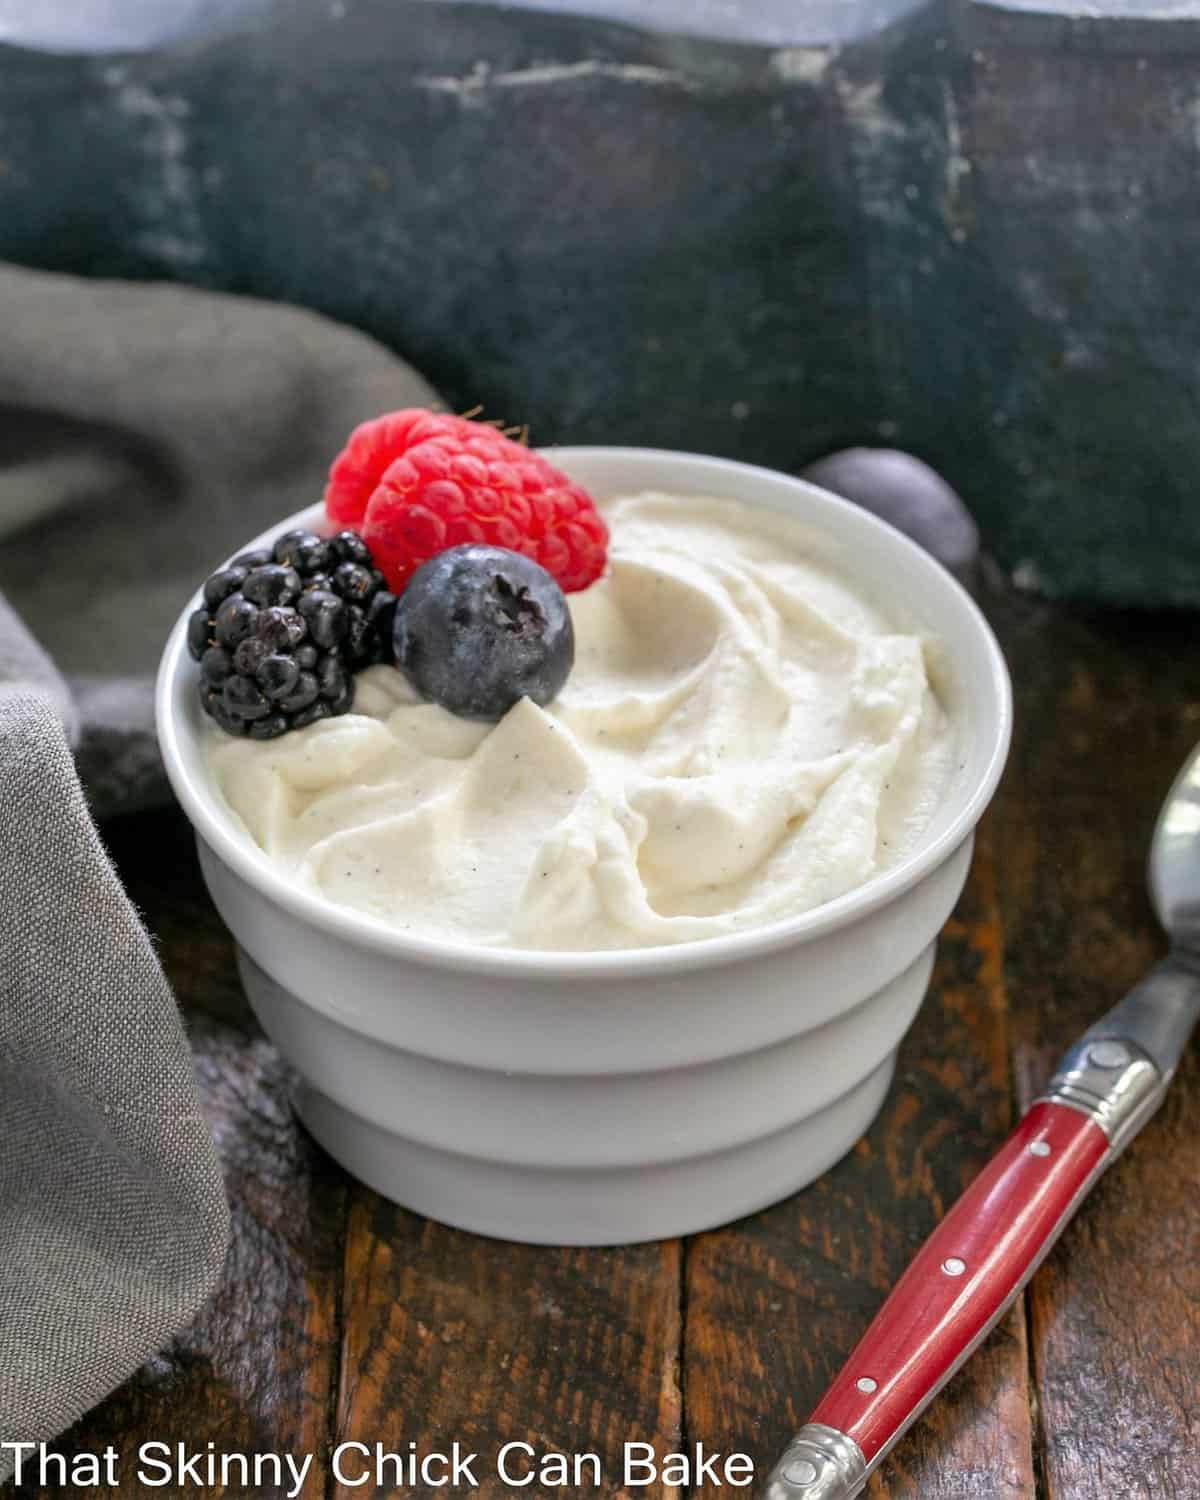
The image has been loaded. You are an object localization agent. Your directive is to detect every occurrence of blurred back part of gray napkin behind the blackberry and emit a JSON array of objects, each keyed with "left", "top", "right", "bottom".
[{"left": 0, "top": 263, "right": 441, "bottom": 818}]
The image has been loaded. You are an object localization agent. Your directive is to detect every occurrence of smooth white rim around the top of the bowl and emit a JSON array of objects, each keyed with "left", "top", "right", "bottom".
[{"left": 155, "top": 444, "right": 1013, "bottom": 981}]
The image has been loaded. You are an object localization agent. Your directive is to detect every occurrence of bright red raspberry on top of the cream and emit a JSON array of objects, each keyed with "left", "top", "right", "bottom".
[{"left": 326, "top": 407, "right": 608, "bottom": 593}]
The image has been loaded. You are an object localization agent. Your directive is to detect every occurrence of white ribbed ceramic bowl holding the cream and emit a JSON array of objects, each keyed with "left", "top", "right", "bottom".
[{"left": 158, "top": 449, "right": 1011, "bottom": 1245}]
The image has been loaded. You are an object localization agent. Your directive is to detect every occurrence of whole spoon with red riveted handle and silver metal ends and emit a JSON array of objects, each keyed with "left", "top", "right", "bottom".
[{"left": 764, "top": 746, "right": 1200, "bottom": 1500}]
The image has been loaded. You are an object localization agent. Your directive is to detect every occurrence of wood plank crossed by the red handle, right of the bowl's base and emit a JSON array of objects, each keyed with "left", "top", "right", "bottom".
[{"left": 684, "top": 825, "right": 1034, "bottom": 1500}]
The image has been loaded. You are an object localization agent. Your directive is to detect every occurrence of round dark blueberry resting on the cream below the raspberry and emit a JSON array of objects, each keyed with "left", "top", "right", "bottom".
[{"left": 395, "top": 545, "right": 575, "bottom": 720}]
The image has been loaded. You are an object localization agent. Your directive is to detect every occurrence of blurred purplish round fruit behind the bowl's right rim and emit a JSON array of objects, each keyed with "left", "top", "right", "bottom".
[{"left": 801, "top": 449, "right": 980, "bottom": 576}]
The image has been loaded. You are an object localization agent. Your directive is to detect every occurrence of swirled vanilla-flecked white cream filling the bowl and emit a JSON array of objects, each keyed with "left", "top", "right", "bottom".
[{"left": 206, "top": 494, "right": 954, "bottom": 951}]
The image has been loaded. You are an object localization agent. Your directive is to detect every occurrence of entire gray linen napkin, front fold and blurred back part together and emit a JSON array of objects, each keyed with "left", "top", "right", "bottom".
[{"left": 0, "top": 267, "right": 432, "bottom": 1481}]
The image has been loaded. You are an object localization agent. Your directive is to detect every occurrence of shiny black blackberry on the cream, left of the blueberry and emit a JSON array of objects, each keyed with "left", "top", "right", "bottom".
[{"left": 188, "top": 530, "right": 396, "bottom": 740}]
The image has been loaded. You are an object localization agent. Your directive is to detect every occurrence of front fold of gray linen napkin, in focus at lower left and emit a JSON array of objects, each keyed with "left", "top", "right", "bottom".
[{"left": 0, "top": 645, "right": 228, "bottom": 1479}]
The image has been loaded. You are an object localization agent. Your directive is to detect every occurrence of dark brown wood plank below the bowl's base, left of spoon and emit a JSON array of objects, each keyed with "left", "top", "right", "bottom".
[{"left": 335, "top": 1188, "right": 681, "bottom": 1500}]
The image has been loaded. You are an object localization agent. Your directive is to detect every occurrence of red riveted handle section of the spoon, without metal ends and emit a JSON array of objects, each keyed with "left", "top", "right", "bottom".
[{"left": 809, "top": 1101, "right": 1110, "bottom": 1464}]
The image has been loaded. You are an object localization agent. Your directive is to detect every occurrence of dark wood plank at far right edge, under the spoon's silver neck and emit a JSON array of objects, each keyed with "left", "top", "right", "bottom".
[{"left": 996, "top": 600, "right": 1200, "bottom": 1500}]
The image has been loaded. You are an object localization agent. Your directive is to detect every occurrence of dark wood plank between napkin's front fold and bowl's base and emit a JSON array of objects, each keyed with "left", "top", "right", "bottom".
[{"left": 20, "top": 813, "right": 348, "bottom": 1500}]
